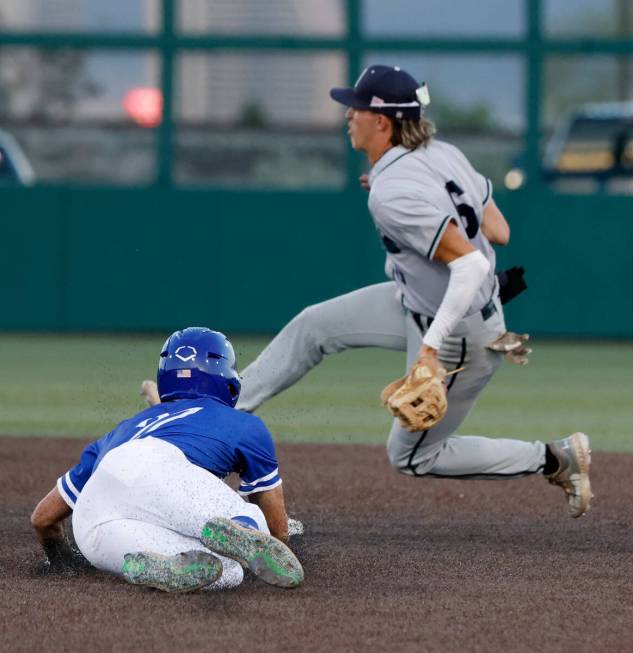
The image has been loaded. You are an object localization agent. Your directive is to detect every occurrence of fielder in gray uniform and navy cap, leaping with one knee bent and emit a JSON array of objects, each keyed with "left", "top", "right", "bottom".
[{"left": 145, "top": 65, "right": 592, "bottom": 517}]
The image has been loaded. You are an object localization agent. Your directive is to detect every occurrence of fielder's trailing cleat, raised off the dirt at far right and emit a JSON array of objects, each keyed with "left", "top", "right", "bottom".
[{"left": 546, "top": 433, "right": 593, "bottom": 517}]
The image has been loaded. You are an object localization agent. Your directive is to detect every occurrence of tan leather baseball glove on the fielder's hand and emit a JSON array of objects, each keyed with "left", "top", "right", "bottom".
[{"left": 380, "top": 356, "right": 448, "bottom": 432}]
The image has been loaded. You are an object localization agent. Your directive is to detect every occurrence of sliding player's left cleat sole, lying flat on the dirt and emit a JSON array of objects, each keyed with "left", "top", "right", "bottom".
[{"left": 121, "top": 551, "right": 222, "bottom": 592}]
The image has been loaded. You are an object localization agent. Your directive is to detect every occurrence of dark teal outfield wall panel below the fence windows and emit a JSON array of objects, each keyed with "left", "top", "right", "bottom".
[{"left": 0, "top": 187, "right": 633, "bottom": 337}]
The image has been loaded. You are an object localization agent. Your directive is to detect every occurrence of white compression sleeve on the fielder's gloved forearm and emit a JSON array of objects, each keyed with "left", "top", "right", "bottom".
[{"left": 420, "top": 250, "right": 490, "bottom": 356}]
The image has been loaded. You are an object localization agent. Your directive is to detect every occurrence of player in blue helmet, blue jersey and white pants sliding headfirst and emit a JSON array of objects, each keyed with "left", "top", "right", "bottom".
[{"left": 31, "top": 327, "right": 303, "bottom": 592}]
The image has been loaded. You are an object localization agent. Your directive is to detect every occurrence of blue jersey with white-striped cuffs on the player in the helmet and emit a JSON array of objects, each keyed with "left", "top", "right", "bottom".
[{"left": 57, "top": 397, "right": 281, "bottom": 508}]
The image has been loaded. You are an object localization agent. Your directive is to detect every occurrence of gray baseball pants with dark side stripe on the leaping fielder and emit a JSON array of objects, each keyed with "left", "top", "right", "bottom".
[{"left": 237, "top": 282, "right": 545, "bottom": 478}]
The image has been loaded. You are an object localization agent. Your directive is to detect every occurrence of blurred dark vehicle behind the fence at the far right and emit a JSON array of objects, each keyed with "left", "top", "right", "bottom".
[{"left": 504, "top": 102, "right": 633, "bottom": 194}]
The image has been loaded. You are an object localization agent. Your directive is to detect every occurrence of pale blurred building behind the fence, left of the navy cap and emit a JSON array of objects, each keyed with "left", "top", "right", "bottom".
[{"left": 176, "top": 0, "right": 345, "bottom": 125}]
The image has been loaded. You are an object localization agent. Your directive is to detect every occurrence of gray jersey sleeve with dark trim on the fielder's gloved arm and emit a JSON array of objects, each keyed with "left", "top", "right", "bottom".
[{"left": 370, "top": 195, "right": 456, "bottom": 259}]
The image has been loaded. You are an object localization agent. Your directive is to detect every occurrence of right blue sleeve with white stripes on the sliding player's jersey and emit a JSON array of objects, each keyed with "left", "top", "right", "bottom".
[{"left": 238, "top": 417, "right": 281, "bottom": 496}]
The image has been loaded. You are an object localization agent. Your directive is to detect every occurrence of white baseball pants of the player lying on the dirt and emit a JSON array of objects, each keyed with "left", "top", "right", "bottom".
[{"left": 72, "top": 437, "right": 269, "bottom": 589}]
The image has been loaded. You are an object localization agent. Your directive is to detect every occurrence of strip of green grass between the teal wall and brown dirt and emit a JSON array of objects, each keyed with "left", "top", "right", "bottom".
[{"left": 0, "top": 334, "right": 633, "bottom": 451}]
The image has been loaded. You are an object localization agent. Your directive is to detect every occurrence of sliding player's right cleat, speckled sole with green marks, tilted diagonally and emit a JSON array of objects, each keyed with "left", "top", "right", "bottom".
[{"left": 200, "top": 517, "right": 303, "bottom": 588}]
